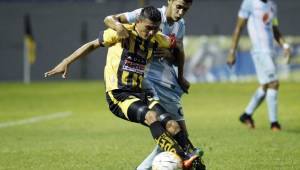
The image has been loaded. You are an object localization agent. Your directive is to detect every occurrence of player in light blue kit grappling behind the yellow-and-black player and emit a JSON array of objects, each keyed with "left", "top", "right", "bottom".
[{"left": 104, "top": 0, "right": 206, "bottom": 170}]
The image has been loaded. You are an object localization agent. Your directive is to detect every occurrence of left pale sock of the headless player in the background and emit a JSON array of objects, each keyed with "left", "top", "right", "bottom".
[{"left": 245, "top": 87, "right": 266, "bottom": 115}]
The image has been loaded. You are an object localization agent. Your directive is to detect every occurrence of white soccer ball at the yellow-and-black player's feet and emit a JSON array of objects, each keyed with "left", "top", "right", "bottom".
[{"left": 152, "top": 152, "right": 182, "bottom": 170}]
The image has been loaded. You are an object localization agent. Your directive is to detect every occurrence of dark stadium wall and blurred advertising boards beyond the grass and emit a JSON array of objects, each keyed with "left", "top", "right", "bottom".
[{"left": 0, "top": 0, "right": 300, "bottom": 82}]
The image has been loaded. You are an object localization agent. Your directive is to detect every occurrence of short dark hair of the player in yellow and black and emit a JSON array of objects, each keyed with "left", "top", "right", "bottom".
[{"left": 139, "top": 6, "right": 161, "bottom": 22}]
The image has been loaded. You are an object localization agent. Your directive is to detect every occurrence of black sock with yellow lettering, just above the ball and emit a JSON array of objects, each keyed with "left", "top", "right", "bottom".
[{"left": 150, "top": 121, "right": 185, "bottom": 157}]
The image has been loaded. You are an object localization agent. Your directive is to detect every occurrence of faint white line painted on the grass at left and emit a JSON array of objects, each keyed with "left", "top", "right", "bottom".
[{"left": 0, "top": 112, "right": 72, "bottom": 128}]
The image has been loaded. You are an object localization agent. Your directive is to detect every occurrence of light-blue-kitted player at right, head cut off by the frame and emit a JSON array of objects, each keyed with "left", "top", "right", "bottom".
[{"left": 227, "top": 0, "right": 290, "bottom": 131}]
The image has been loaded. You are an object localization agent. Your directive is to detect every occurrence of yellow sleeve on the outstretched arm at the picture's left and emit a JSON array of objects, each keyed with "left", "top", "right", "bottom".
[{"left": 98, "top": 29, "right": 120, "bottom": 47}]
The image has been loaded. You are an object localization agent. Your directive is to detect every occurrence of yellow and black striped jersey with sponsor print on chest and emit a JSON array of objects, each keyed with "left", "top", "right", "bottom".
[{"left": 99, "top": 24, "right": 174, "bottom": 92}]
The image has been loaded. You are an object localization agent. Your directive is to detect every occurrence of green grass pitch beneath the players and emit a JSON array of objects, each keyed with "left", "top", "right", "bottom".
[{"left": 0, "top": 81, "right": 300, "bottom": 170}]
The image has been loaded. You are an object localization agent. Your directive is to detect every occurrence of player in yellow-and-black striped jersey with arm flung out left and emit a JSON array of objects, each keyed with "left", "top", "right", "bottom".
[{"left": 45, "top": 6, "right": 198, "bottom": 169}]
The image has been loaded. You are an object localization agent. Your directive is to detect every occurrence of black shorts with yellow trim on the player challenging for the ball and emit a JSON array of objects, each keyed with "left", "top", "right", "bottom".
[{"left": 106, "top": 89, "right": 158, "bottom": 124}]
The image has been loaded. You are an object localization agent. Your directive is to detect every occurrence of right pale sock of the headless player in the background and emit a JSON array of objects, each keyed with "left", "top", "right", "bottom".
[{"left": 266, "top": 89, "right": 278, "bottom": 123}]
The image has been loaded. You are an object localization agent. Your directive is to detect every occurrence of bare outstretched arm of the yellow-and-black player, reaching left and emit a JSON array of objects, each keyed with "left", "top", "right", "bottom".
[{"left": 44, "top": 39, "right": 100, "bottom": 78}]
